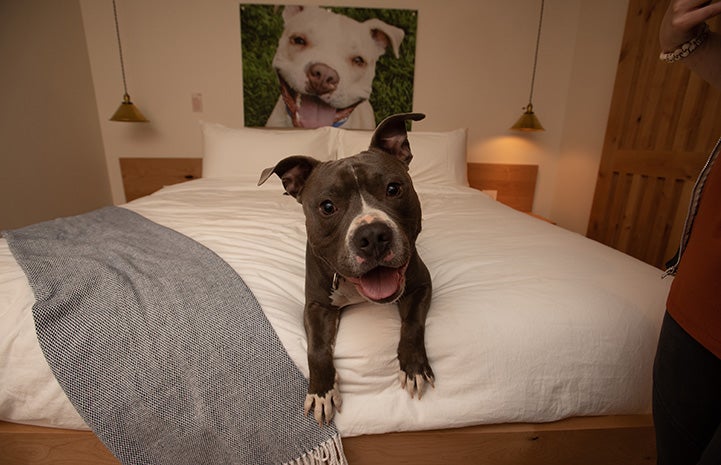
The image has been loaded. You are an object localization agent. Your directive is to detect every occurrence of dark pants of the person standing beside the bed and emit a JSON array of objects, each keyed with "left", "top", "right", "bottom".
[{"left": 653, "top": 313, "right": 721, "bottom": 465}]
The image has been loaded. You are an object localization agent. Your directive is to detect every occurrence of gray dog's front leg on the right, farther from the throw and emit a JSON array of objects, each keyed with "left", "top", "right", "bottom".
[{"left": 398, "top": 254, "right": 435, "bottom": 399}]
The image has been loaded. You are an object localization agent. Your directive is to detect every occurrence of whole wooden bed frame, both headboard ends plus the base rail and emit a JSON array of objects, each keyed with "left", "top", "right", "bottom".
[{"left": 0, "top": 158, "right": 656, "bottom": 465}]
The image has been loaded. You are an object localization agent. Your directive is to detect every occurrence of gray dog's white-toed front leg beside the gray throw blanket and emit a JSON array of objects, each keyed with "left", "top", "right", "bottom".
[{"left": 304, "top": 302, "right": 342, "bottom": 425}]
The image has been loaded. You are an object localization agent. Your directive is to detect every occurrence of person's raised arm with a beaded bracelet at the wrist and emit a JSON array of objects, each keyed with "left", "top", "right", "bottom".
[{"left": 659, "top": 0, "right": 721, "bottom": 89}]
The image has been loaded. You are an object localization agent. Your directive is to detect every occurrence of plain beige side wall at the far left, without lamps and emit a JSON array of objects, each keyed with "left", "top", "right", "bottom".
[{"left": 0, "top": 0, "right": 112, "bottom": 229}]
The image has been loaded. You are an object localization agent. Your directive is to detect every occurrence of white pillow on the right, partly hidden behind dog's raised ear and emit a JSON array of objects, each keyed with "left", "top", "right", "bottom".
[{"left": 338, "top": 129, "right": 468, "bottom": 186}]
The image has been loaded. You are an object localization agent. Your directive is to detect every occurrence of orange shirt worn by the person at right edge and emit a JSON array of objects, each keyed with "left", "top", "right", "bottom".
[{"left": 666, "top": 153, "right": 721, "bottom": 359}]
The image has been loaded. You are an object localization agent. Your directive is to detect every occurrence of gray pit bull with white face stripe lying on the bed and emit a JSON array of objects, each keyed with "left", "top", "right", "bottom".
[{"left": 258, "top": 113, "right": 435, "bottom": 424}]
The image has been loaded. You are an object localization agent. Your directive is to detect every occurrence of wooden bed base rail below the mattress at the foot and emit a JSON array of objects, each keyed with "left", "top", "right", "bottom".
[{"left": 0, "top": 415, "right": 656, "bottom": 465}]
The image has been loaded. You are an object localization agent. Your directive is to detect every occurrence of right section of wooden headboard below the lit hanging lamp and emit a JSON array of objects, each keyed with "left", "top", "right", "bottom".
[{"left": 468, "top": 163, "right": 538, "bottom": 212}]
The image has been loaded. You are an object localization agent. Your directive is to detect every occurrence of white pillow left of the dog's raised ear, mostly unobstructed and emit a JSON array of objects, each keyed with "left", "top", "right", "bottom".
[{"left": 200, "top": 121, "right": 337, "bottom": 179}]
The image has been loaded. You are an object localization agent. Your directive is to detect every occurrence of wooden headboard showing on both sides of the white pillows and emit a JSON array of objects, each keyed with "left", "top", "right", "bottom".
[{"left": 120, "top": 158, "right": 538, "bottom": 212}]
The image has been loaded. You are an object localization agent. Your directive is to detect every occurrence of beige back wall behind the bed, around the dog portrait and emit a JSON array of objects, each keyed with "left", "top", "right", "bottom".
[{"left": 80, "top": 0, "right": 628, "bottom": 233}]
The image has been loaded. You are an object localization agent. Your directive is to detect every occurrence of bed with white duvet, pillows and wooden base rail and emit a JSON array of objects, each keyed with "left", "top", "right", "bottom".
[{"left": 0, "top": 123, "right": 671, "bottom": 464}]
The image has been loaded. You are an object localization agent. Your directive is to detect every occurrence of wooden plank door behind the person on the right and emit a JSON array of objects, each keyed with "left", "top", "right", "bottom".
[{"left": 587, "top": 0, "right": 721, "bottom": 268}]
